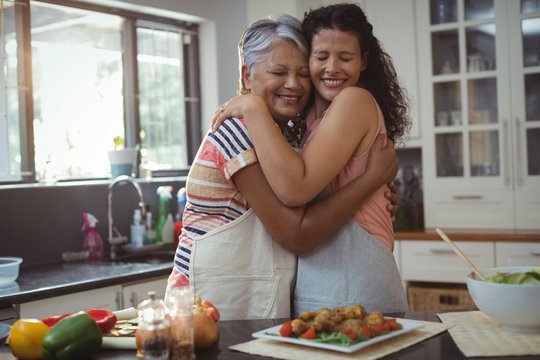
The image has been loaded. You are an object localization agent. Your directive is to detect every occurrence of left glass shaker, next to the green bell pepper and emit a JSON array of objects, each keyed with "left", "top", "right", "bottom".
[{"left": 137, "top": 291, "right": 170, "bottom": 360}]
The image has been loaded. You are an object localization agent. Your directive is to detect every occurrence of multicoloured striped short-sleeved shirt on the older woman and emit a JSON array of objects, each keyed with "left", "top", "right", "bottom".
[{"left": 174, "top": 118, "right": 258, "bottom": 280}]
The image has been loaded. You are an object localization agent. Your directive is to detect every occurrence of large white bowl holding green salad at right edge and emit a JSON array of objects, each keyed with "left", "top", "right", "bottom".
[{"left": 466, "top": 266, "right": 540, "bottom": 333}]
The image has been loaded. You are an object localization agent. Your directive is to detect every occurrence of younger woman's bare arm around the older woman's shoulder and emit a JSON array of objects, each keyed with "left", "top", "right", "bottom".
[{"left": 216, "top": 87, "right": 378, "bottom": 206}]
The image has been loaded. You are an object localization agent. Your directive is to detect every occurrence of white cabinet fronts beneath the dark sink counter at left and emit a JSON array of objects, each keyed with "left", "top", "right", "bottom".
[{"left": 19, "top": 276, "right": 167, "bottom": 319}]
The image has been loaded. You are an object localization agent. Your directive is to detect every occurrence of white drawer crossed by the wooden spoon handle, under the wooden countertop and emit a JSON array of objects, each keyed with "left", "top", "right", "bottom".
[{"left": 400, "top": 240, "right": 495, "bottom": 283}]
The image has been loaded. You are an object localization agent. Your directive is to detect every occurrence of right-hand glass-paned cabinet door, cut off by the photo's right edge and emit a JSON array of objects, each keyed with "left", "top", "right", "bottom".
[{"left": 507, "top": 0, "right": 540, "bottom": 229}]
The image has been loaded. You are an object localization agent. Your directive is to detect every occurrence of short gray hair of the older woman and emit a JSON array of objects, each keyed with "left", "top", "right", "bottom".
[{"left": 238, "top": 15, "right": 309, "bottom": 94}]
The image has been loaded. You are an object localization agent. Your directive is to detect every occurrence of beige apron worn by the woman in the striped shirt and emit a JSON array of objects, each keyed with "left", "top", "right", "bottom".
[{"left": 189, "top": 209, "right": 296, "bottom": 320}]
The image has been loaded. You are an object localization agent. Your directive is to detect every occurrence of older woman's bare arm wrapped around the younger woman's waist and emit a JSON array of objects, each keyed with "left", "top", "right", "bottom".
[{"left": 233, "top": 136, "right": 399, "bottom": 255}]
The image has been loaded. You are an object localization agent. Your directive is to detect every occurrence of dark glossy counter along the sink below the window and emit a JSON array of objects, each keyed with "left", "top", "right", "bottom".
[{"left": 0, "top": 256, "right": 173, "bottom": 308}]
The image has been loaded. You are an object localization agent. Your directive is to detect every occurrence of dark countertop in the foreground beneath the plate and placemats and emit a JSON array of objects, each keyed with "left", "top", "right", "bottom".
[{"left": 0, "top": 312, "right": 538, "bottom": 360}]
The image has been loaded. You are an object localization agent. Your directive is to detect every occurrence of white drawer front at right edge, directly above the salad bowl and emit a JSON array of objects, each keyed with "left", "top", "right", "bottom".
[{"left": 495, "top": 242, "right": 540, "bottom": 267}]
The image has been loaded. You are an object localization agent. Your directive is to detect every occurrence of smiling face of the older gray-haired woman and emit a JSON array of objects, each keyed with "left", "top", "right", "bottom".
[{"left": 243, "top": 40, "right": 311, "bottom": 122}]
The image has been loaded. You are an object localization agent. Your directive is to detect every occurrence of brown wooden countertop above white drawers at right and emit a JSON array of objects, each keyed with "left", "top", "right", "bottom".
[{"left": 394, "top": 229, "right": 540, "bottom": 242}]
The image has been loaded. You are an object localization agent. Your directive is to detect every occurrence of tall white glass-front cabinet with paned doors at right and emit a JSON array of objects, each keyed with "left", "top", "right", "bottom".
[{"left": 416, "top": 0, "right": 540, "bottom": 229}]
